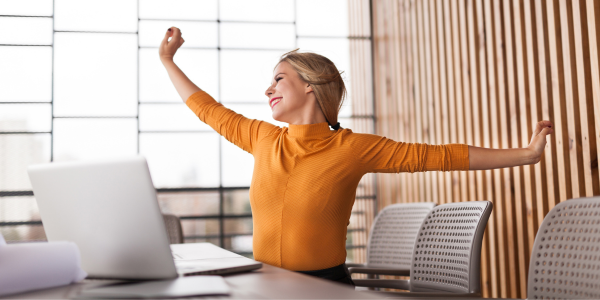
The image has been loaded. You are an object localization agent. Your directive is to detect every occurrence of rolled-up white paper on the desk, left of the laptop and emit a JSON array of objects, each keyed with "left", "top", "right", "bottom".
[{"left": 0, "top": 234, "right": 87, "bottom": 296}]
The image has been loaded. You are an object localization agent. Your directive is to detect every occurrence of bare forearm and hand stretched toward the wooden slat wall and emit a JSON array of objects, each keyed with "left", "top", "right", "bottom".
[{"left": 469, "top": 121, "right": 554, "bottom": 170}]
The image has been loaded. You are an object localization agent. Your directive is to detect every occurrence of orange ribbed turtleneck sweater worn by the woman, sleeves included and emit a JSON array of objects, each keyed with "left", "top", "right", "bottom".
[{"left": 186, "top": 91, "right": 469, "bottom": 271}]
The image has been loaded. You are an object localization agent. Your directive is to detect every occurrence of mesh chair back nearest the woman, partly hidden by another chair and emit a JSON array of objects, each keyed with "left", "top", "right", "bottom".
[{"left": 367, "top": 202, "right": 435, "bottom": 270}]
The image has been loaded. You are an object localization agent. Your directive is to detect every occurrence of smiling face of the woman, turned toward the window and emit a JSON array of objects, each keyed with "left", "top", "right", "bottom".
[{"left": 265, "top": 61, "right": 315, "bottom": 124}]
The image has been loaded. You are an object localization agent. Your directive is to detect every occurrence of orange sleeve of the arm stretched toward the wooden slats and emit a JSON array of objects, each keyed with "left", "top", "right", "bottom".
[{"left": 356, "top": 134, "right": 469, "bottom": 173}]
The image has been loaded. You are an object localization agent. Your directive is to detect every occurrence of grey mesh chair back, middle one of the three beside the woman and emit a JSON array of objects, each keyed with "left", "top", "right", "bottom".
[{"left": 410, "top": 201, "right": 492, "bottom": 294}]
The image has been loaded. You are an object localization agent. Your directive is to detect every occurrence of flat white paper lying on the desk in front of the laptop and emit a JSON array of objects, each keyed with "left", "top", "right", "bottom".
[{"left": 79, "top": 276, "right": 229, "bottom": 298}]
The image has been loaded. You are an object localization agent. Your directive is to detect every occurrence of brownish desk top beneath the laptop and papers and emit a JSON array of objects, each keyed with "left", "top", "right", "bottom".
[{"left": 0, "top": 264, "right": 389, "bottom": 299}]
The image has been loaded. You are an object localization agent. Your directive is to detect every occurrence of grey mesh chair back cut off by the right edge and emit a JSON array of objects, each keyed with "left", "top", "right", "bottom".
[{"left": 527, "top": 197, "right": 600, "bottom": 299}]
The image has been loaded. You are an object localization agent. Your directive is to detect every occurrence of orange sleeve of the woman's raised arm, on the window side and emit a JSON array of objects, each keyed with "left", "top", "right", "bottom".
[{"left": 185, "top": 91, "right": 281, "bottom": 153}]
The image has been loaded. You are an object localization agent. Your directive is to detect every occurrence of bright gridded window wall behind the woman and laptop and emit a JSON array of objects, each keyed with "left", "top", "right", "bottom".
[{"left": 0, "top": 0, "right": 375, "bottom": 261}]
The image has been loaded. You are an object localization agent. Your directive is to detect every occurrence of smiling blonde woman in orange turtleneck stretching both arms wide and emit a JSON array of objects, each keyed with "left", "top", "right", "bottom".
[{"left": 159, "top": 27, "right": 552, "bottom": 284}]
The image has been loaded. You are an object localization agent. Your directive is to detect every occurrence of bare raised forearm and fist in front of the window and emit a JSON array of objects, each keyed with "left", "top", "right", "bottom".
[{"left": 158, "top": 27, "right": 200, "bottom": 102}]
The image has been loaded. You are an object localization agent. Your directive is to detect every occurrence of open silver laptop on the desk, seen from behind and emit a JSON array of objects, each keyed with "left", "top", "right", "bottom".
[{"left": 28, "top": 156, "right": 262, "bottom": 280}]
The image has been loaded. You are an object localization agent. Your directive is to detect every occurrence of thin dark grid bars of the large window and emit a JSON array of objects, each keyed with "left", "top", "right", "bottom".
[{"left": 0, "top": 0, "right": 377, "bottom": 254}]
